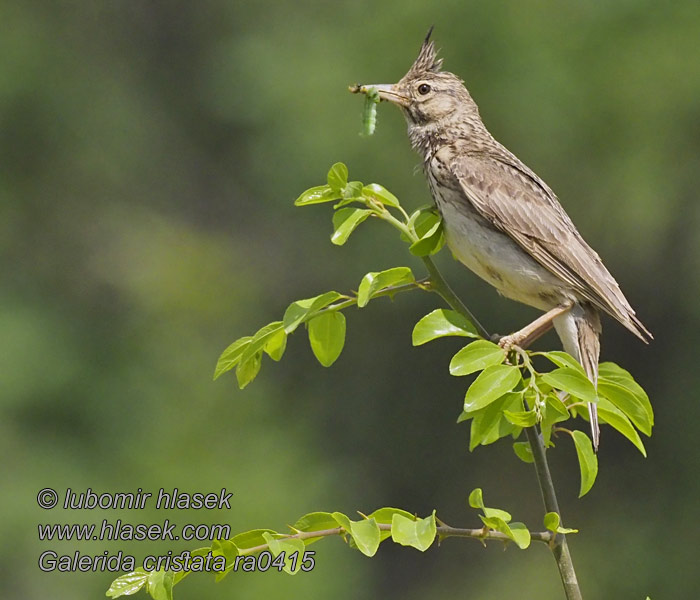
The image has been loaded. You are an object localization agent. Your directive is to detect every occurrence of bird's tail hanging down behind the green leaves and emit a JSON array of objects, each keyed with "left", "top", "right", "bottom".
[{"left": 554, "top": 304, "right": 601, "bottom": 452}]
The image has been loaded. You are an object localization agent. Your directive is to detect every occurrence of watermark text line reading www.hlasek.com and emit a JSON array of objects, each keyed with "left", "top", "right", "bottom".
[{"left": 39, "top": 519, "right": 231, "bottom": 542}]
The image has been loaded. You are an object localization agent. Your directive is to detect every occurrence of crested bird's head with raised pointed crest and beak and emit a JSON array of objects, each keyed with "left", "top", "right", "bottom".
[{"left": 353, "top": 27, "right": 479, "bottom": 129}]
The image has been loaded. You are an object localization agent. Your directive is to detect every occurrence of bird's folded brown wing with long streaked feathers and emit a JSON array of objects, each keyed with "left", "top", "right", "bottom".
[{"left": 450, "top": 149, "right": 651, "bottom": 341}]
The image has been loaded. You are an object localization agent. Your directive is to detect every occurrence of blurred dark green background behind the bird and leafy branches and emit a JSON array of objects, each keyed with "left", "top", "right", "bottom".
[{"left": 0, "top": 0, "right": 700, "bottom": 600}]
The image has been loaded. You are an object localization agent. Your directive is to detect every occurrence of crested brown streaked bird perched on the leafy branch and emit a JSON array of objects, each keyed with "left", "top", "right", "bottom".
[{"left": 356, "top": 27, "right": 653, "bottom": 451}]
